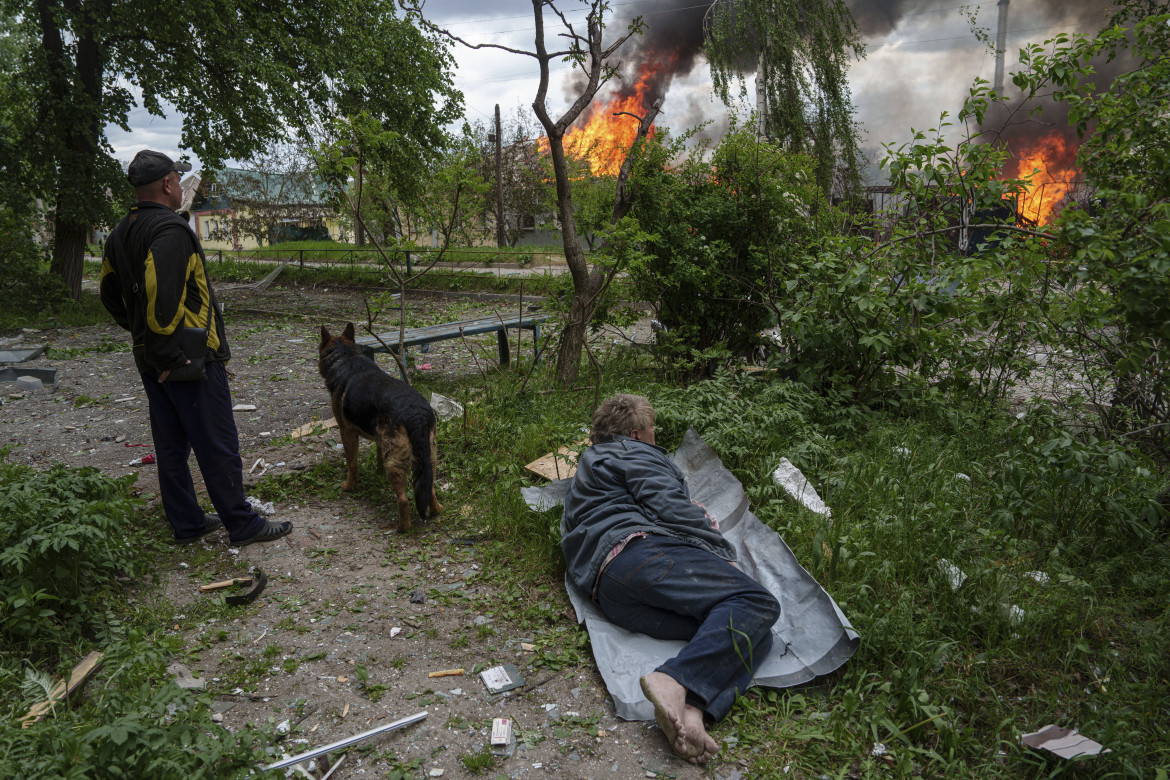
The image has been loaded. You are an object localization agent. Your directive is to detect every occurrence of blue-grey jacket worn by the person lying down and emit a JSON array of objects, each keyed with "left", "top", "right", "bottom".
[{"left": 560, "top": 436, "right": 736, "bottom": 593}]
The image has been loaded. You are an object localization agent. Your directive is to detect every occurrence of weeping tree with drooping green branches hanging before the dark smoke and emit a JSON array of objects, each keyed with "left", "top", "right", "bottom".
[{"left": 706, "top": 0, "right": 863, "bottom": 193}]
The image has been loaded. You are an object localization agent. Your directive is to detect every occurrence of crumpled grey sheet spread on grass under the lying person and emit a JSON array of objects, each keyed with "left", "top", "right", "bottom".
[{"left": 521, "top": 430, "right": 859, "bottom": 720}]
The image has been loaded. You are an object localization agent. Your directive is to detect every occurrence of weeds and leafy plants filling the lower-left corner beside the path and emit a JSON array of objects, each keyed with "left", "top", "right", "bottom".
[{"left": 0, "top": 451, "right": 284, "bottom": 780}]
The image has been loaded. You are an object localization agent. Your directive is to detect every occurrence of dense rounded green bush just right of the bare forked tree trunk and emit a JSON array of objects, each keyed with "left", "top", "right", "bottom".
[{"left": 629, "top": 130, "right": 832, "bottom": 374}]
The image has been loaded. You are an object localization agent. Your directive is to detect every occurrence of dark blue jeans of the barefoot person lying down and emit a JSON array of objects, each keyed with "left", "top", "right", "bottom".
[{"left": 597, "top": 536, "right": 780, "bottom": 720}]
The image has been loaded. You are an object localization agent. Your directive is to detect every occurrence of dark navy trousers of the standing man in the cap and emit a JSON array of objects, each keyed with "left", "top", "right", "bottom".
[{"left": 142, "top": 363, "right": 264, "bottom": 541}]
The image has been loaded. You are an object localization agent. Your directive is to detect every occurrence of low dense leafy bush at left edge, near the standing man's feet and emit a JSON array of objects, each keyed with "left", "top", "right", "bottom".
[{"left": 0, "top": 460, "right": 149, "bottom": 654}]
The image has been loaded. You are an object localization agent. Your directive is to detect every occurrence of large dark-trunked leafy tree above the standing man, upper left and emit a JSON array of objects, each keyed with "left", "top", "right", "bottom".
[{"left": 0, "top": 0, "right": 458, "bottom": 297}]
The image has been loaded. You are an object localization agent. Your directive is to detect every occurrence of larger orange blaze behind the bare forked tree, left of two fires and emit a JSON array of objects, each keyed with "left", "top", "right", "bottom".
[{"left": 541, "top": 55, "right": 675, "bottom": 177}]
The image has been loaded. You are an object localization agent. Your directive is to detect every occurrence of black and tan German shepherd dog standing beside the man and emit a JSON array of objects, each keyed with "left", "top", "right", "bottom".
[{"left": 317, "top": 323, "right": 442, "bottom": 533}]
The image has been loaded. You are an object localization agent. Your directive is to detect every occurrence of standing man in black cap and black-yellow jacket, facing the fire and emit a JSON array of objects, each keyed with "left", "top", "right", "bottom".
[{"left": 102, "top": 150, "right": 293, "bottom": 546}]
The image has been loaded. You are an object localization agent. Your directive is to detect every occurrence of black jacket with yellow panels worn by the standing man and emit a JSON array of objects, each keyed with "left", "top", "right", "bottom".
[{"left": 102, "top": 201, "right": 232, "bottom": 373}]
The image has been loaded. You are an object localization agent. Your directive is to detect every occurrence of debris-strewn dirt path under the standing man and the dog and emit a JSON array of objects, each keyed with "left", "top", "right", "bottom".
[{"left": 0, "top": 290, "right": 738, "bottom": 780}]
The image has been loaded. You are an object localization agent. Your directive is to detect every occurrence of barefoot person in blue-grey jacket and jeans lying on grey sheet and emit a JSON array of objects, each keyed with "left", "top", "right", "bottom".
[{"left": 560, "top": 395, "right": 780, "bottom": 764}]
